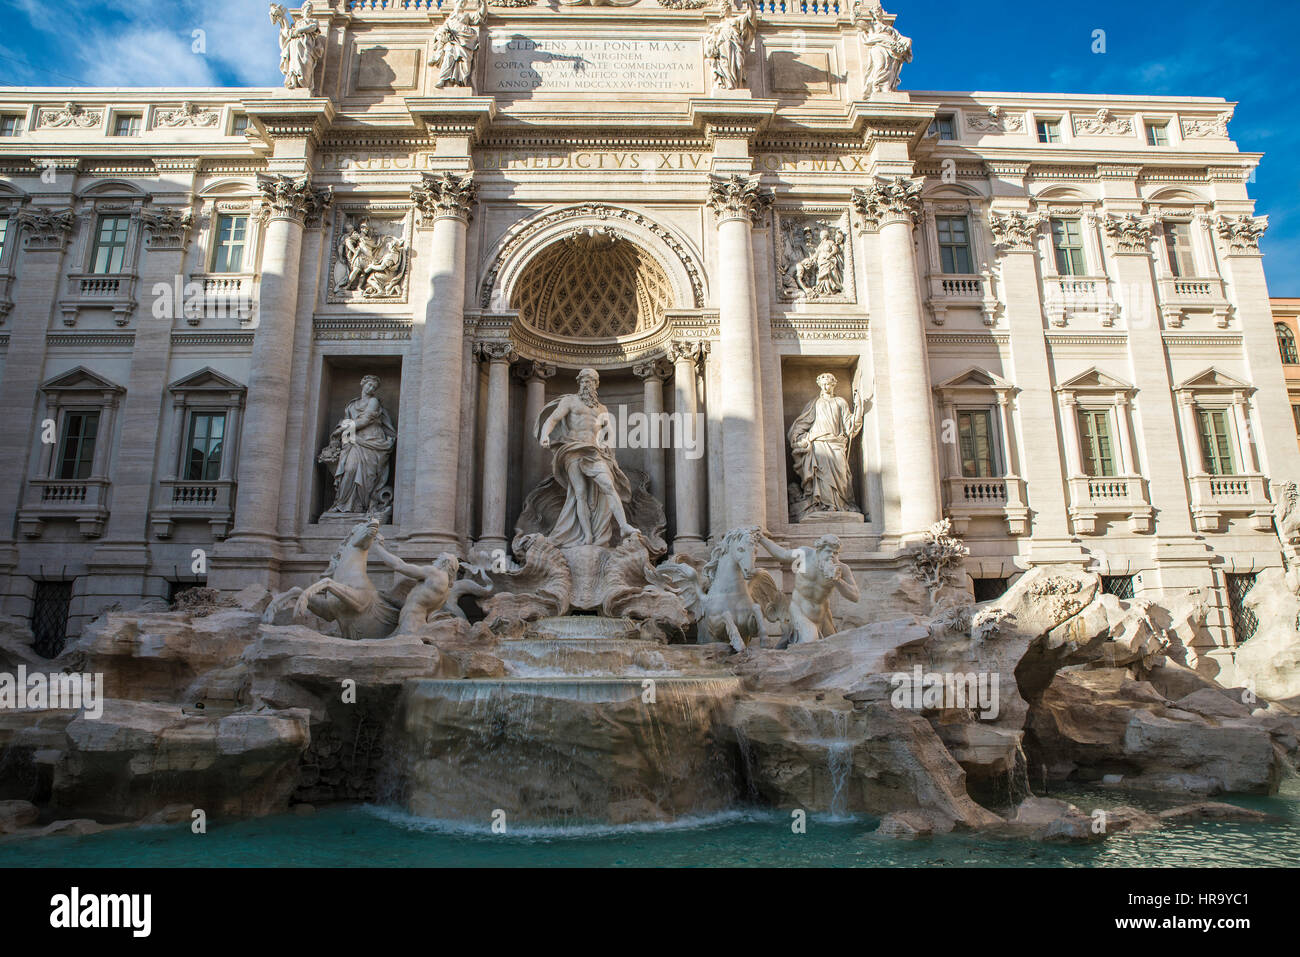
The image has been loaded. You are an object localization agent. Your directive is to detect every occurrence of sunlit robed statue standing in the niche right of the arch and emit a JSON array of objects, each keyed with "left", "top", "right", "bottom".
[{"left": 788, "top": 372, "right": 866, "bottom": 521}]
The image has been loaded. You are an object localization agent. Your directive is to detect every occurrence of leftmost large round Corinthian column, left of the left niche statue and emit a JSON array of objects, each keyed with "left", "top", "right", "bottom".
[{"left": 231, "top": 176, "right": 333, "bottom": 542}]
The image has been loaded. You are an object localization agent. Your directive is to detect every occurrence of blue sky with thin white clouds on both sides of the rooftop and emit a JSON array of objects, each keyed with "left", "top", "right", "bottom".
[{"left": 0, "top": 0, "right": 1300, "bottom": 296}]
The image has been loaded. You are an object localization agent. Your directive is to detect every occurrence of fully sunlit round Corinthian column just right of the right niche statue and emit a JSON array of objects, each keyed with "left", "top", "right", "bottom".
[{"left": 853, "top": 177, "right": 943, "bottom": 537}]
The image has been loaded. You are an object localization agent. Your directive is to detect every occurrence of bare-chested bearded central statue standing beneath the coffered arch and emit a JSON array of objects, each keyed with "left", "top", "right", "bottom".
[{"left": 537, "top": 369, "right": 637, "bottom": 547}]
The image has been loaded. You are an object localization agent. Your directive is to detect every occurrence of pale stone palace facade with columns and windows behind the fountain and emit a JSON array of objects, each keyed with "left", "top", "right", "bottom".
[{"left": 0, "top": 0, "right": 1300, "bottom": 657}]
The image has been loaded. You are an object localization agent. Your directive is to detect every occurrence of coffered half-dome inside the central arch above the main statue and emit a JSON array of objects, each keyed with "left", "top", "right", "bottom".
[{"left": 511, "top": 229, "right": 673, "bottom": 339}]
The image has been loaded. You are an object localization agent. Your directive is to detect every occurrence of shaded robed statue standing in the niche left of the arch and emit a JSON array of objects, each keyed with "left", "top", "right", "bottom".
[{"left": 320, "top": 376, "right": 398, "bottom": 515}]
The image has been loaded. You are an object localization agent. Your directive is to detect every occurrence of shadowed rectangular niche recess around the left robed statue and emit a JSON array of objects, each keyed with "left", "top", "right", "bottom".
[{"left": 306, "top": 356, "right": 406, "bottom": 524}]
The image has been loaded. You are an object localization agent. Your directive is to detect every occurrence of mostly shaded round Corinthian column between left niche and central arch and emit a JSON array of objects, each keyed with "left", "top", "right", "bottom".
[{"left": 411, "top": 167, "right": 477, "bottom": 547}]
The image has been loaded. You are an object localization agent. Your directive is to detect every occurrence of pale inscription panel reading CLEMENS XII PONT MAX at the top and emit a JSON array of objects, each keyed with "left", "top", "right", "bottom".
[{"left": 486, "top": 35, "right": 705, "bottom": 92}]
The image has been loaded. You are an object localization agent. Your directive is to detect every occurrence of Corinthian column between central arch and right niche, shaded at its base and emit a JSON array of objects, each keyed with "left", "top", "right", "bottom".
[{"left": 709, "top": 174, "right": 772, "bottom": 528}]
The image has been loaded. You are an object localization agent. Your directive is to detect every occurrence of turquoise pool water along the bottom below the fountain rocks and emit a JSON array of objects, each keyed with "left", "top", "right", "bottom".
[{"left": 0, "top": 787, "right": 1300, "bottom": 867}]
